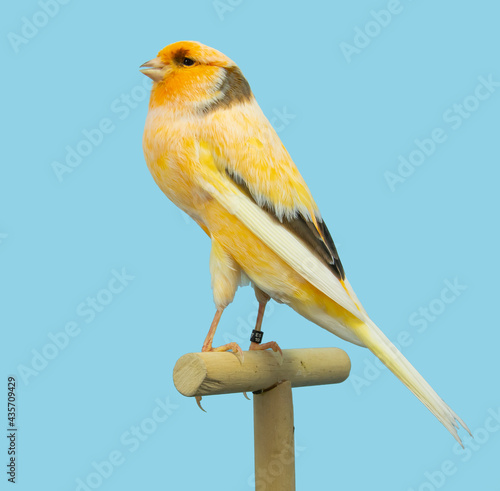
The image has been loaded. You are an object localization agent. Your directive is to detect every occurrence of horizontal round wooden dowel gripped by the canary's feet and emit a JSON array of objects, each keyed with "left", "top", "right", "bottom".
[{"left": 174, "top": 348, "right": 351, "bottom": 397}]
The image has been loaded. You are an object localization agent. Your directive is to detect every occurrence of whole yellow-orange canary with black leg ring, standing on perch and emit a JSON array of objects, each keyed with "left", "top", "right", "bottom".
[{"left": 140, "top": 41, "right": 470, "bottom": 443}]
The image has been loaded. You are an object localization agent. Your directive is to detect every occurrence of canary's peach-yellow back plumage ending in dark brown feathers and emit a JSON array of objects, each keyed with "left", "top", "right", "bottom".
[{"left": 201, "top": 101, "right": 352, "bottom": 280}]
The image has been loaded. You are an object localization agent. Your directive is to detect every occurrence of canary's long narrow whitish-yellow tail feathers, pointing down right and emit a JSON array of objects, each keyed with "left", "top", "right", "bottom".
[{"left": 356, "top": 320, "right": 472, "bottom": 447}]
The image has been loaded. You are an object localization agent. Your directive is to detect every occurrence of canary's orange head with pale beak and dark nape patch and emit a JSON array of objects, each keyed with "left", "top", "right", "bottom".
[{"left": 140, "top": 41, "right": 253, "bottom": 113}]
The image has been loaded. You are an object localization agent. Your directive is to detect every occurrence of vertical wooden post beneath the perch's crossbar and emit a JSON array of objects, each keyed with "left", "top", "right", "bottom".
[{"left": 253, "top": 380, "right": 295, "bottom": 491}]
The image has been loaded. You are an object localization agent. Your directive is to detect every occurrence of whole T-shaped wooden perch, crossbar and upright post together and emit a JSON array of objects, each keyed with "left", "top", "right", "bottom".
[{"left": 174, "top": 348, "right": 351, "bottom": 491}]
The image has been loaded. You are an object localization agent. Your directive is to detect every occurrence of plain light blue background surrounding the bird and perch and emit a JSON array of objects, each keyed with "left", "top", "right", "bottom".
[{"left": 0, "top": 0, "right": 500, "bottom": 491}]
